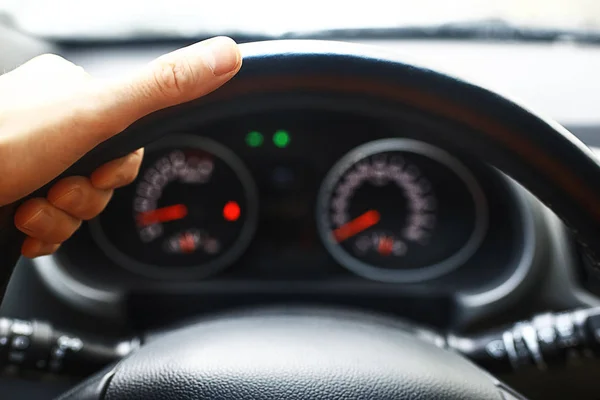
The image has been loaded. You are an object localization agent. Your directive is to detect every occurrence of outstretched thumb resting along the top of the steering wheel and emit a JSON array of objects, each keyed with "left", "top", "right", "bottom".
[{"left": 89, "top": 37, "right": 242, "bottom": 140}]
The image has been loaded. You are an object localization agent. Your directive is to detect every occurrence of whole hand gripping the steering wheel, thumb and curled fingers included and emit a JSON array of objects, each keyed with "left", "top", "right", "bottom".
[{"left": 0, "top": 37, "right": 241, "bottom": 257}]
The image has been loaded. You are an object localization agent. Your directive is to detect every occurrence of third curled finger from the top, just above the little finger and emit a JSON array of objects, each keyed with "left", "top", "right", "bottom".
[{"left": 14, "top": 198, "right": 81, "bottom": 244}]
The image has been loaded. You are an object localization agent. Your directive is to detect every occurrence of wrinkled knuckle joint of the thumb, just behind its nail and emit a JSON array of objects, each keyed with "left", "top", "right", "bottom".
[{"left": 154, "top": 59, "right": 196, "bottom": 97}]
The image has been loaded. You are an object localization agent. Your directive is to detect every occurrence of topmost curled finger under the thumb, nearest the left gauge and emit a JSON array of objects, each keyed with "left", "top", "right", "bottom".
[{"left": 91, "top": 149, "right": 144, "bottom": 190}]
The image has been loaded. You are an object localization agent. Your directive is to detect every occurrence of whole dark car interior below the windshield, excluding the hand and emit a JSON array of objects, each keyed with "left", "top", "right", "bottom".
[{"left": 0, "top": 1, "right": 600, "bottom": 400}]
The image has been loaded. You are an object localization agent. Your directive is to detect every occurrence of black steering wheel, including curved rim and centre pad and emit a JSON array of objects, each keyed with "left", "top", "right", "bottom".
[{"left": 0, "top": 41, "right": 600, "bottom": 400}]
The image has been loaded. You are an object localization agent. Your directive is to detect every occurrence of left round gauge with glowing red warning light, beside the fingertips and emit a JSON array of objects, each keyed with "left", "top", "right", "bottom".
[{"left": 91, "top": 136, "right": 257, "bottom": 277}]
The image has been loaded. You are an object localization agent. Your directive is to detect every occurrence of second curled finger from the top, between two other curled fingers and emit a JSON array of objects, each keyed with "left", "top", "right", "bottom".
[{"left": 47, "top": 176, "right": 112, "bottom": 220}]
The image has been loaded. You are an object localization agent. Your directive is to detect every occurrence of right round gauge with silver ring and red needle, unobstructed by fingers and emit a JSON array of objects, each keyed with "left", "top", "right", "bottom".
[{"left": 317, "top": 139, "right": 487, "bottom": 282}]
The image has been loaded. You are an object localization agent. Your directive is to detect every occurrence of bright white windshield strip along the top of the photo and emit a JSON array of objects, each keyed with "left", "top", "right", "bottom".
[{"left": 0, "top": 0, "right": 600, "bottom": 38}]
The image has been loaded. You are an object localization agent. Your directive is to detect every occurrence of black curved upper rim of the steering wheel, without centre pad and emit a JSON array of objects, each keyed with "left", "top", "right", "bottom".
[{"left": 5, "top": 41, "right": 600, "bottom": 399}]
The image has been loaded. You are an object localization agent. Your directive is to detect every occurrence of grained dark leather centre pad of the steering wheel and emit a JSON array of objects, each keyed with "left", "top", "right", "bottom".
[{"left": 104, "top": 309, "right": 502, "bottom": 400}]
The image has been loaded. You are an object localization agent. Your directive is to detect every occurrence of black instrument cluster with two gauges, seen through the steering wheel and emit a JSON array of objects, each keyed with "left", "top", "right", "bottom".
[{"left": 42, "top": 107, "right": 533, "bottom": 332}]
